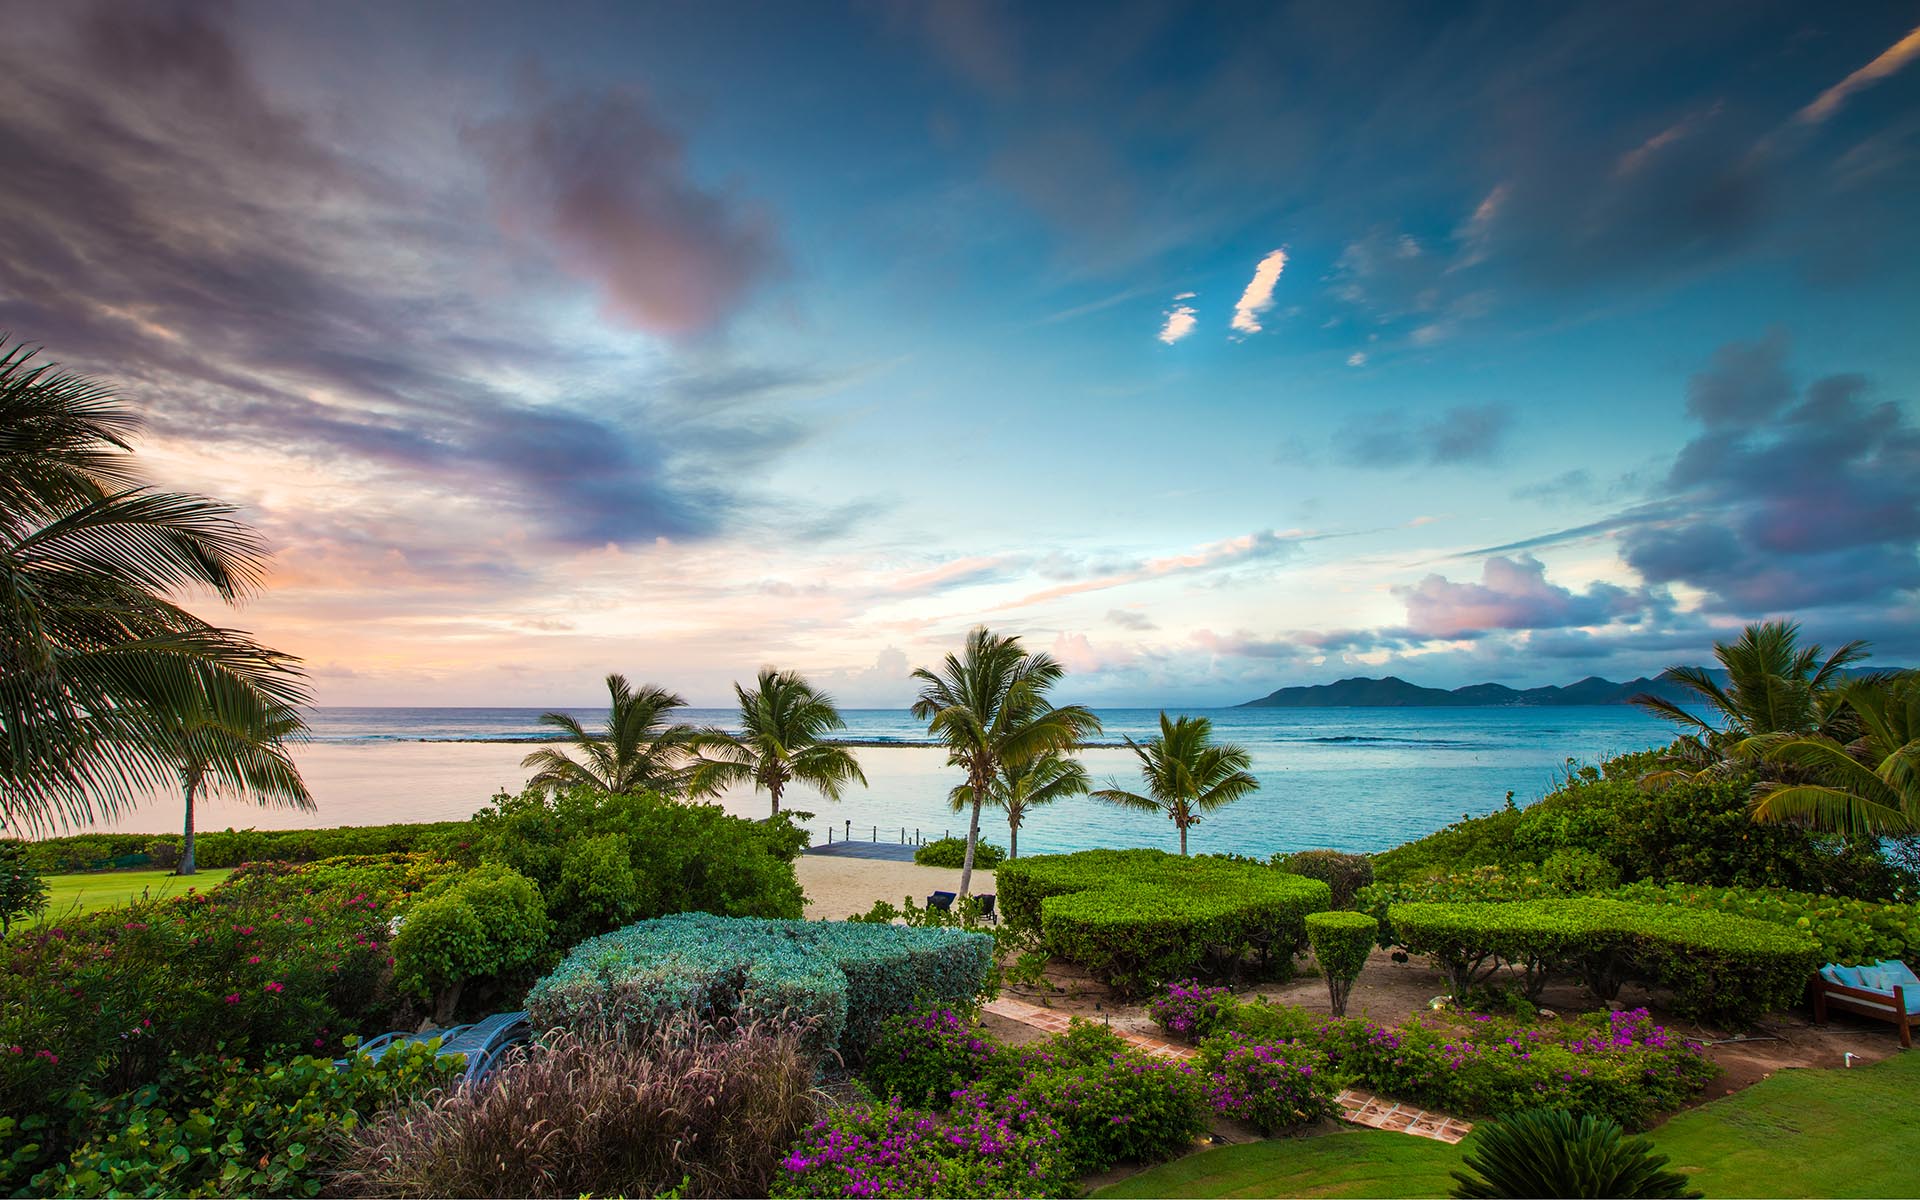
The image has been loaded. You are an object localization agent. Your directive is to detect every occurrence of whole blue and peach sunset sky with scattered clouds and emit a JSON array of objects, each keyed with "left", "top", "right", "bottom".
[{"left": 0, "top": 0, "right": 1920, "bottom": 707}]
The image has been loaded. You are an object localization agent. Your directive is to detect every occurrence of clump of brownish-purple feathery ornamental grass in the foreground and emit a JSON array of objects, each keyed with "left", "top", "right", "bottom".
[{"left": 334, "top": 1025, "right": 816, "bottom": 1196}]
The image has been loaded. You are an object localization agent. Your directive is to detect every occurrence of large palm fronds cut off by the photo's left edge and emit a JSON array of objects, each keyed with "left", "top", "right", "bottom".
[{"left": 0, "top": 338, "right": 307, "bottom": 831}]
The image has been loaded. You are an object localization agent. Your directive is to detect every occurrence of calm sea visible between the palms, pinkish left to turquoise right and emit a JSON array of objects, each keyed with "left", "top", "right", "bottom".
[{"left": 86, "top": 707, "right": 1670, "bottom": 854}]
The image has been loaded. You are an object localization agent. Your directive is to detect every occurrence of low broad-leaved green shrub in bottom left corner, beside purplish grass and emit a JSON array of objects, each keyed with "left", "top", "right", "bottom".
[{"left": 33, "top": 1043, "right": 459, "bottom": 1196}]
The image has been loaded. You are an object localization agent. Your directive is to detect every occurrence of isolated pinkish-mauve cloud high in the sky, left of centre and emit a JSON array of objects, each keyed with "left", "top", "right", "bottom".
[{"left": 468, "top": 88, "right": 780, "bottom": 336}]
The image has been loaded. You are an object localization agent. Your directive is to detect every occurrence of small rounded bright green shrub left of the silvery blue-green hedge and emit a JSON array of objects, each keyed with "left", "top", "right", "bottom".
[{"left": 394, "top": 864, "right": 549, "bottom": 1021}]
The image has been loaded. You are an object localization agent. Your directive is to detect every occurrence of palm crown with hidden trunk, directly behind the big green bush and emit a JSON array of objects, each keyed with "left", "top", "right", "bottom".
[{"left": 520, "top": 674, "right": 699, "bottom": 795}]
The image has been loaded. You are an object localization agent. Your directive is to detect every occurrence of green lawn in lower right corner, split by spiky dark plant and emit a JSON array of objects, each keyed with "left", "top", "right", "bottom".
[{"left": 1096, "top": 1052, "right": 1920, "bottom": 1196}]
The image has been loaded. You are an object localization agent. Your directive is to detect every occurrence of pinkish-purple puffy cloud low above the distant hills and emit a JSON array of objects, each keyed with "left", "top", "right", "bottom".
[{"left": 1394, "top": 555, "right": 1668, "bottom": 637}]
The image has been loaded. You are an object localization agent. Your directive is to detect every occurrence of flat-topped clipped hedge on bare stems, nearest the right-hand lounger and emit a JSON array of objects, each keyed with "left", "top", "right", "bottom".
[{"left": 1388, "top": 897, "right": 1820, "bottom": 1023}]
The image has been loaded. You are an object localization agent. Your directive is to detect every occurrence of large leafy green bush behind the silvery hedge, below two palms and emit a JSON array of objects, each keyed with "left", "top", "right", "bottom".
[{"left": 470, "top": 789, "right": 806, "bottom": 948}]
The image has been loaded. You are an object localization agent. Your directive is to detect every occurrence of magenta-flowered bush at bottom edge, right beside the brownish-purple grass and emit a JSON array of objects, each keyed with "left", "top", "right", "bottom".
[{"left": 772, "top": 1092, "right": 1075, "bottom": 1200}]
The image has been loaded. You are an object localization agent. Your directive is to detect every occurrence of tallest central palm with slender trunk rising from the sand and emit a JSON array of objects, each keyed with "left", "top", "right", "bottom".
[{"left": 912, "top": 626, "right": 1100, "bottom": 900}]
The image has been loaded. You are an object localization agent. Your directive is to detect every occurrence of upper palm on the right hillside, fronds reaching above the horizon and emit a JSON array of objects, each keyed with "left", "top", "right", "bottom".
[{"left": 1634, "top": 620, "right": 1868, "bottom": 781}]
